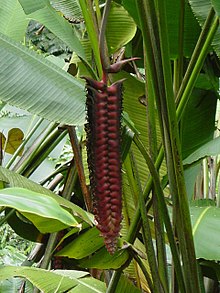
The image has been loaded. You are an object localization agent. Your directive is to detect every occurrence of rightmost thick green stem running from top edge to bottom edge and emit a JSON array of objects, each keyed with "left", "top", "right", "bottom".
[{"left": 155, "top": 1, "right": 201, "bottom": 292}]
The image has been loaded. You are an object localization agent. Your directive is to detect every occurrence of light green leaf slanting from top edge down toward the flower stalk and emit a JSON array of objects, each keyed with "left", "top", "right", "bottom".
[{"left": 19, "top": 0, "right": 85, "bottom": 58}]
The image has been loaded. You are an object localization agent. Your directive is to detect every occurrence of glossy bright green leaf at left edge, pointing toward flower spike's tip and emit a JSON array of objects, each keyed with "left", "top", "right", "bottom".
[{"left": 0, "top": 188, "right": 78, "bottom": 233}]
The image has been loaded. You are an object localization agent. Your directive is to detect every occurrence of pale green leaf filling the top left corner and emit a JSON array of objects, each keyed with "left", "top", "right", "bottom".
[{"left": 0, "top": 0, "right": 29, "bottom": 41}]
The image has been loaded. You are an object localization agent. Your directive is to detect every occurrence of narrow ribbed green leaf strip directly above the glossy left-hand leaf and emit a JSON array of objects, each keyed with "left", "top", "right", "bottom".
[{"left": 0, "top": 166, "right": 94, "bottom": 225}]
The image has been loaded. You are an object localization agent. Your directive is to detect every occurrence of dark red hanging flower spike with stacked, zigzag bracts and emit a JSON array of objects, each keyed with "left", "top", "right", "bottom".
[{"left": 85, "top": 78, "right": 122, "bottom": 254}]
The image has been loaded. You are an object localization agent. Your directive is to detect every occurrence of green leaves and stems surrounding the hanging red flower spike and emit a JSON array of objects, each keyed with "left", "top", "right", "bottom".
[{"left": 0, "top": 0, "right": 220, "bottom": 293}]
